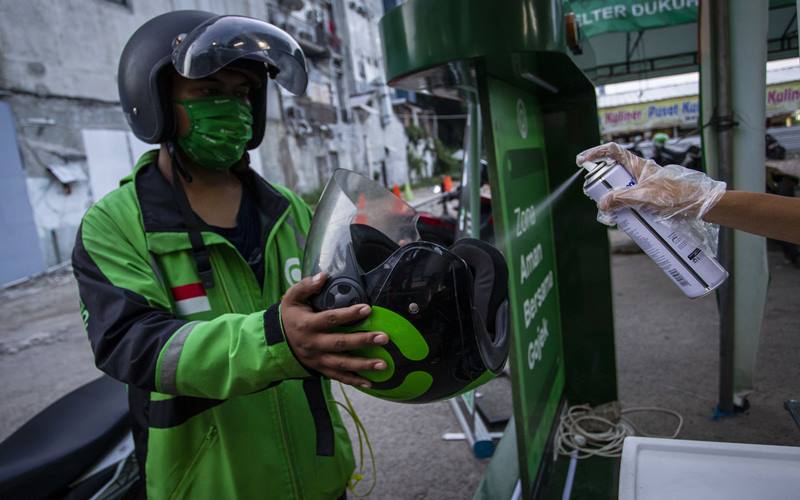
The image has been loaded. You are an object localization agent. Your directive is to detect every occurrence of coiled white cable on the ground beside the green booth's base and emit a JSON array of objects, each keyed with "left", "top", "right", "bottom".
[{"left": 554, "top": 403, "right": 683, "bottom": 459}]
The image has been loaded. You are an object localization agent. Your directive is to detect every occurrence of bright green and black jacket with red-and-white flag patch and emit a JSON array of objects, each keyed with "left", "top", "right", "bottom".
[{"left": 72, "top": 151, "right": 353, "bottom": 500}]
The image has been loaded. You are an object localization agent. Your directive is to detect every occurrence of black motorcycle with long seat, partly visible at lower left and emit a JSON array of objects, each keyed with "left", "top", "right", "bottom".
[{"left": 0, "top": 375, "right": 139, "bottom": 500}]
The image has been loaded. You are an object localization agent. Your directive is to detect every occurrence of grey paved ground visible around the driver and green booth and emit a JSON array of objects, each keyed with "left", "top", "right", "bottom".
[{"left": 0, "top": 244, "right": 800, "bottom": 500}]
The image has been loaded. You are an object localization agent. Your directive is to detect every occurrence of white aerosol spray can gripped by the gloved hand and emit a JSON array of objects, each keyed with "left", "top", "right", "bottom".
[{"left": 581, "top": 159, "right": 728, "bottom": 299}]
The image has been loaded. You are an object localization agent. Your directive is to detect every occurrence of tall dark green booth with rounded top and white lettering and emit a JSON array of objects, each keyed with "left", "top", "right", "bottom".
[{"left": 380, "top": 0, "right": 618, "bottom": 498}]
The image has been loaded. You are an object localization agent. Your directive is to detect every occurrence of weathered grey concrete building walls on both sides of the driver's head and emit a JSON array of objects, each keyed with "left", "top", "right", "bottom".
[{"left": 0, "top": 0, "right": 407, "bottom": 265}]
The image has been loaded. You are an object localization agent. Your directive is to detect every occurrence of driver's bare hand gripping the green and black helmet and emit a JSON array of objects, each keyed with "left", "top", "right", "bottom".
[{"left": 281, "top": 273, "right": 389, "bottom": 388}]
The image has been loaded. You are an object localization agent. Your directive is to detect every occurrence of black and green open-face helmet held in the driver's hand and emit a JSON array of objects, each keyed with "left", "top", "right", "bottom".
[{"left": 303, "top": 170, "right": 510, "bottom": 403}]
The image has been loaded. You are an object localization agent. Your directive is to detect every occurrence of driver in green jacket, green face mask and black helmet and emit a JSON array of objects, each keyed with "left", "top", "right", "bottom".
[{"left": 73, "top": 11, "right": 388, "bottom": 499}]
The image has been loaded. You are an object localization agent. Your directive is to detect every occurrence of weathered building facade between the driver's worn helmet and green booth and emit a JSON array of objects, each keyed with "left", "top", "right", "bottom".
[{"left": 265, "top": 0, "right": 408, "bottom": 192}]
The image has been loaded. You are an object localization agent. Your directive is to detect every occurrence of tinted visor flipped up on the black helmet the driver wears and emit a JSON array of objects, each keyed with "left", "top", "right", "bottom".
[{"left": 172, "top": 16, "right": 308, "bottom": 95}]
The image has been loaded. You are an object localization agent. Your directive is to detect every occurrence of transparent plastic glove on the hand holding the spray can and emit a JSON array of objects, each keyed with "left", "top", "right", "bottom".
[{"left": 576, "top": 142, "right": 726, "bottom": 254}]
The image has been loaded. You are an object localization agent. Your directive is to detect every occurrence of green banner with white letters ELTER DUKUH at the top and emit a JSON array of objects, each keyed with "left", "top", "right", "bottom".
[{"left": 564, "top": 0, "right": 699, "bottom": 37}]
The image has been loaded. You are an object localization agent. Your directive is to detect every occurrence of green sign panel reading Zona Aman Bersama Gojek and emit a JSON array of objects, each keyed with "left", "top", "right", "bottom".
[{"left": 485, "top": 77, "right": 564, "bottom": 485}]
